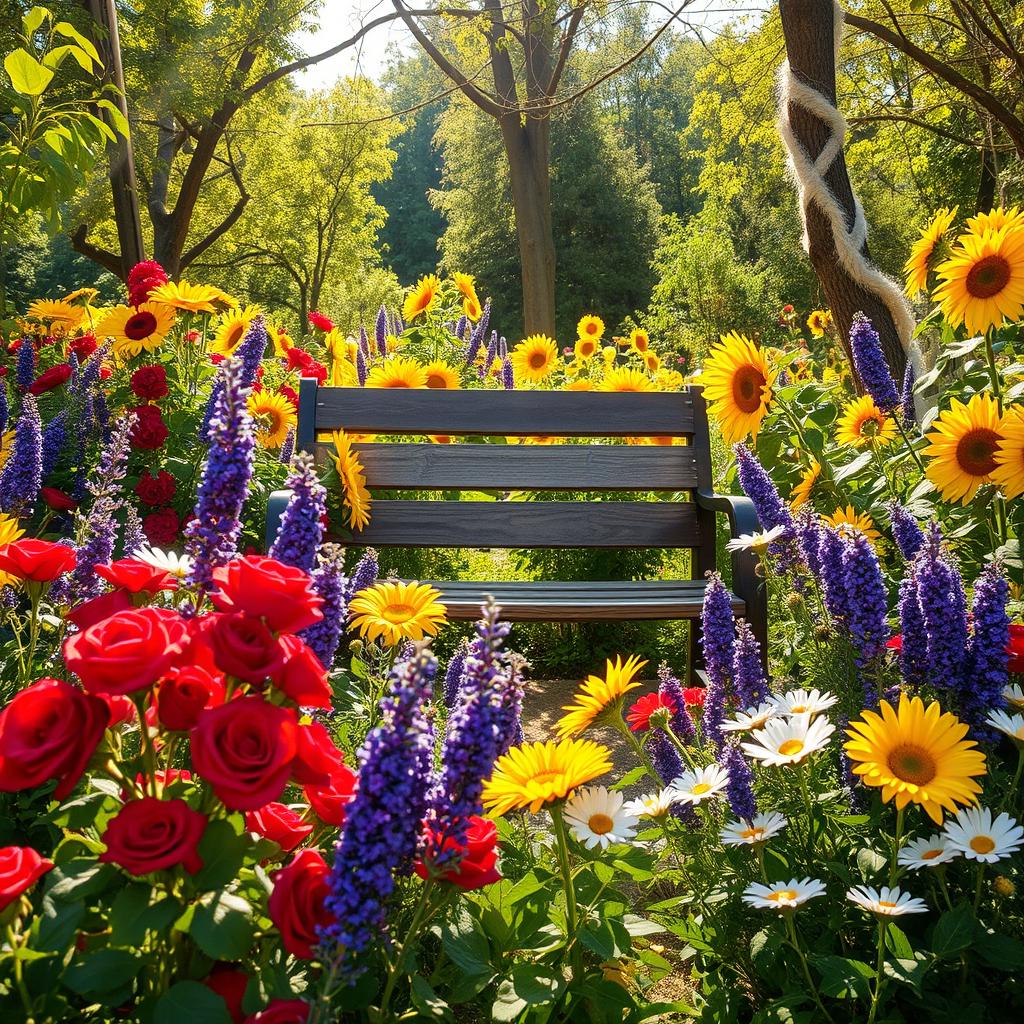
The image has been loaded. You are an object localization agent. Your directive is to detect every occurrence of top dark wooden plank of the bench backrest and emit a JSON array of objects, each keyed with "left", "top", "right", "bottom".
[{"left": 316, "top": 387, "right": 693, "bottom": 437}]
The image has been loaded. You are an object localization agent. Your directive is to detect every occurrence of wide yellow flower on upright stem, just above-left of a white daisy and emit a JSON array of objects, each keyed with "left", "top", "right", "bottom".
[{"left": 481, "top": 739, "right": 611, "bottom": 816}]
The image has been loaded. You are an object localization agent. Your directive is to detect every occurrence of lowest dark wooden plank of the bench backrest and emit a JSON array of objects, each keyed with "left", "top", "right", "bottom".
[{"left": 351, "top": 501, "right": 699, "bottom": 548}]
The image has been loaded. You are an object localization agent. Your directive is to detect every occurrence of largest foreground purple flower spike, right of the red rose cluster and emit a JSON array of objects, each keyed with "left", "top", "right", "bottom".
[{"left": 321, "top": 653, "right": 437, "bottom": 980}]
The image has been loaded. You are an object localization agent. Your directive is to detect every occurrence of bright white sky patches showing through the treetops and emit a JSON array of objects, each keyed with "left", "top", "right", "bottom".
[{"left": 296, "top": 0, "right": 769, "bottom": 89}]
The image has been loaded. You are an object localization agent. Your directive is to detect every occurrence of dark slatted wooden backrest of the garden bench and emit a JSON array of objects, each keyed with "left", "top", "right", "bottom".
[{"left": 296, "top": 378, "right": 714, "bottom": 571}]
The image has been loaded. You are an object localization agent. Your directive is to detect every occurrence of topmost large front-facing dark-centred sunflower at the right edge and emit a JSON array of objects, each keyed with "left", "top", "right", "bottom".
[{"left": 934, "top": 224, "right": 1024, "bottom": 334}]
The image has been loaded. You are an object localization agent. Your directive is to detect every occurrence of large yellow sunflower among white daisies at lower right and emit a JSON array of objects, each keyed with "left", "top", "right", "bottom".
[{"left": 845, "top": 693, "right": 986, "bottom": 824}]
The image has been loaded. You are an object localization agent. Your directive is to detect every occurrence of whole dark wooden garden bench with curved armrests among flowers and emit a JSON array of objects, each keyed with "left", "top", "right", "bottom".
[{"left": 267, "top": 378, "right": 767, "bottom": 670}]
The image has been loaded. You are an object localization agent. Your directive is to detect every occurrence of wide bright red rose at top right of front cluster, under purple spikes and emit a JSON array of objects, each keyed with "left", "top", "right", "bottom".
[{"left": 211, "top": 555, "right": 324, "bottom": 633}]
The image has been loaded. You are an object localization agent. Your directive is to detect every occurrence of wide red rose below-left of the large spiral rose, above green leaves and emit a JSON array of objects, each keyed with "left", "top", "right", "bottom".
[{"left": 99, "top": 797, "right": 206, "bottom": 874}]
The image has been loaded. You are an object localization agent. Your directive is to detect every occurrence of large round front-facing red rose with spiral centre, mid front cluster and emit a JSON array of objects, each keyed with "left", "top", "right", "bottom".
[{"left": 191, "top": 695, "right": 299, "bottom": 811}]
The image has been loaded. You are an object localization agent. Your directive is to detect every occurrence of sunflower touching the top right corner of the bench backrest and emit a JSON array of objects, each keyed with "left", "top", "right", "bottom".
[{"left": 699, "top": 332, "right": 778, "bottom": 444}]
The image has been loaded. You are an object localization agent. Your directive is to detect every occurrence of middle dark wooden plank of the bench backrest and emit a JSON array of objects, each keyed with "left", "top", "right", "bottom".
[{"left": 329, "top": 442, "right": 697, "bottom": 490}]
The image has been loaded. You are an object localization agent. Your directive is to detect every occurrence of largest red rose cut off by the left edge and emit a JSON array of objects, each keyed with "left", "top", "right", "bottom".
[{"left": 0, "top": 679, "right": 111, "bottom": 800}]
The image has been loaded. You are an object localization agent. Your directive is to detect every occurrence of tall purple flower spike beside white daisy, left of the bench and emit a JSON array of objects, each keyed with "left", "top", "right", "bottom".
[{"left": 185, "top": 358, "right": 256, "bottom": 588}]
